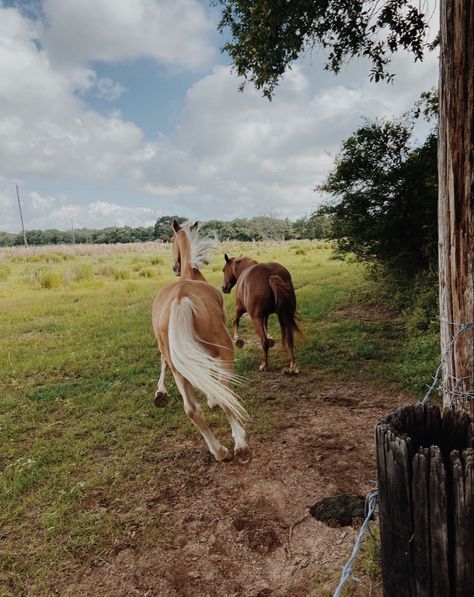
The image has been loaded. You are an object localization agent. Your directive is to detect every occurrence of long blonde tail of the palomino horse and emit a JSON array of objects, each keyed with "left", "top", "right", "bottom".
[{"left": 168, "top": 297, "right": 249, "bottom": 422}]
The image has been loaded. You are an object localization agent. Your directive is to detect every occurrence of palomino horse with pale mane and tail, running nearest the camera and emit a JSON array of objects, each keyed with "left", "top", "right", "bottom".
[{"left": 152, "top": 221, "right": 251, "bottom": 463}]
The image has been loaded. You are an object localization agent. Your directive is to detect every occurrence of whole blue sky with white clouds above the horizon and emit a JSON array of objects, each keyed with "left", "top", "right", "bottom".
[{"left": 0, "top": 0, "right": 438, "bottom": 232}]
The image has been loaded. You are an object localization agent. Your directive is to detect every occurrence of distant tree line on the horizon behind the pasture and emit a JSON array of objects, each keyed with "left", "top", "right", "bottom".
[{"left": 0, "top": 211, "right": 331, "bottom": 247}]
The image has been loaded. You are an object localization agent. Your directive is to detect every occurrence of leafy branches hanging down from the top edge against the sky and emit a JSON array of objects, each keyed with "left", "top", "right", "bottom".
[{"left": 214, "top": 0, "right": 427, "bottom": 98}]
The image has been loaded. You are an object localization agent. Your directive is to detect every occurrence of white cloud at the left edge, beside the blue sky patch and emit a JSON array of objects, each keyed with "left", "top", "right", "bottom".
[{"left": 0, "top": 7, "right": 143, "bottom": 179}]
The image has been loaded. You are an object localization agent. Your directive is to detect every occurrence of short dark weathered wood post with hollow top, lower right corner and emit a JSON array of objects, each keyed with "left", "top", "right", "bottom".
[{"left": 375, "top": 404, "right": 474, "bottom": 597}]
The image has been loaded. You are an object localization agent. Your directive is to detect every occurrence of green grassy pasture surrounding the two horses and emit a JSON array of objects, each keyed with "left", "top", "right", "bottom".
[{"left": 0, "top": 241, "right": 434, "bottom": 595}]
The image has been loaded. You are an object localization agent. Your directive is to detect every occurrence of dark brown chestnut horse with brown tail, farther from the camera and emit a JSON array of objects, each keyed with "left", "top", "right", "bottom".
[{"left": 222, "top": 255, "right": 299, "bottom": 375}]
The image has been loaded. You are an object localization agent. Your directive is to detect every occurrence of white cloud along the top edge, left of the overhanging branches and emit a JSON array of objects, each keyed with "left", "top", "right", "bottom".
[{"left": 43, "top": 0, "right": 216, "bottom": 69}]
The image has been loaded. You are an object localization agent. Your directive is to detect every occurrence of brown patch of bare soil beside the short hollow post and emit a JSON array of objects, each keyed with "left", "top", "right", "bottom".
[{"left": 57, "top": 372, "right": 404, "bottom": 597}]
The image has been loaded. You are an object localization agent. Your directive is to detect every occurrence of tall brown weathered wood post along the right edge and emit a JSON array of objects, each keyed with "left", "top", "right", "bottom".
[{"left": 438, "top": 0, "right": 474, "bottom": 410}]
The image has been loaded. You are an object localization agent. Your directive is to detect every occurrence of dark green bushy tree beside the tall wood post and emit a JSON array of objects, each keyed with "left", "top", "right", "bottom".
[{"left": 319, "top": 114, "right": 438, "bottom": 284}]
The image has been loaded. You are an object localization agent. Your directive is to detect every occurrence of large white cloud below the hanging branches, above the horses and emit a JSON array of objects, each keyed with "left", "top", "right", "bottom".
[{"left": 133, "top": 46, "right": 437, "bottom": 219}]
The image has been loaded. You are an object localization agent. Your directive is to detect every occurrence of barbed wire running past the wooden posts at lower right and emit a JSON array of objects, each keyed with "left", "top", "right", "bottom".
[{"left": 333, "top": 318, "right": 474, "bottom": 597}]
